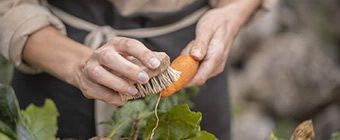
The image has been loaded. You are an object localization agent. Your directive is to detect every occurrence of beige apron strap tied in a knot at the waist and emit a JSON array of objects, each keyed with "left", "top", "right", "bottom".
[{"left": 46, "top": 3, "right": 209, "bottom": 48}]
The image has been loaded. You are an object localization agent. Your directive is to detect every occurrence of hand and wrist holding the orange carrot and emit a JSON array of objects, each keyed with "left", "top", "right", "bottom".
[{"left": 182, "top": 0, "right": 258, "bottom": 87}]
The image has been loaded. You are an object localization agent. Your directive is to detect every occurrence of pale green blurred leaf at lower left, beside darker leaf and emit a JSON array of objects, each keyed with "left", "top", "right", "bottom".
[{"left": 20, "top": 99, "right": 58, "bottom": 140}]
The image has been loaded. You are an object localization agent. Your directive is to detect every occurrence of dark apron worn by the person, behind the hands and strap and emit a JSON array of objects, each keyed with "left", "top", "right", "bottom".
[{"left": 12, "top": 0, "right": 231, "bottom": 140}]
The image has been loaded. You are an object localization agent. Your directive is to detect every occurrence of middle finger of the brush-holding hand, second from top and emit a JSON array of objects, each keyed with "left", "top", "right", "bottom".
[{"left": 95, "top": 48, "right": 149, "bottom": 84}]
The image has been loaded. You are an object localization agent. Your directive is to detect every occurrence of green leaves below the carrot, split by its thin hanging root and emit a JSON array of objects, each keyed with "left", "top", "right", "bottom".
[{"left": 103, "top": 88, "right": 216, "bottom": 140}]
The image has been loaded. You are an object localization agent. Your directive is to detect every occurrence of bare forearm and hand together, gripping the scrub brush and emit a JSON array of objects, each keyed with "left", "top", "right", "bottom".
[{"left": 22, "top": 26, "right": 160, "bottom": 105}]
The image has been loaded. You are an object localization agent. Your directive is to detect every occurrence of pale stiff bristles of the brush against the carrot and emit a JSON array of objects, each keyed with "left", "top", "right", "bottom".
[{"left": 120, "top": 67, "right": 181, "bottom": 101}]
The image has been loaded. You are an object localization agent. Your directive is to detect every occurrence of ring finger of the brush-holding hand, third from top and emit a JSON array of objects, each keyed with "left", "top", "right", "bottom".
[{"left": 87, "top": 61, "right": 138, "bottom": 95}]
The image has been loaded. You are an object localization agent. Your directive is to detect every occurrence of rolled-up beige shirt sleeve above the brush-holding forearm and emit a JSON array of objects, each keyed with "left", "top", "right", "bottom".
[{"left": 0, "top": 0, "right": 65, "bottom": 74}]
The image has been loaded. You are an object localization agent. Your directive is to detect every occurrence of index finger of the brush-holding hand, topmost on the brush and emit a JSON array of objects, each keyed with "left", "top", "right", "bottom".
[{"left": 113, "top": 37, "right": 161, "bottom": 69}]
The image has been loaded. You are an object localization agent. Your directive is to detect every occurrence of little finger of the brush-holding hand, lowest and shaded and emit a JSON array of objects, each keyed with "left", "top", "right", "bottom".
[{"left": 80, "top": 78, "right": 126, "bottom": 106}]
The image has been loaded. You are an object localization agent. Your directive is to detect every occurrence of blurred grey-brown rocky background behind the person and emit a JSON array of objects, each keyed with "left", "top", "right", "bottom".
[{"left": 0, "top": 0, "right": 340, "bottom": 140}]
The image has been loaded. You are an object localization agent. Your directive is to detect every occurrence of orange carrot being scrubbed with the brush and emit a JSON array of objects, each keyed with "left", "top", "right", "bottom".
[{"left": 160, "top": 55, "right": 199, "bottom": 97}]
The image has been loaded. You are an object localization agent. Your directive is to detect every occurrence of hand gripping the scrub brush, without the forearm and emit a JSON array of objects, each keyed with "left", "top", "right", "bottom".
[{"left": 72, "top": 37, "right": 160, "bottom": 105}]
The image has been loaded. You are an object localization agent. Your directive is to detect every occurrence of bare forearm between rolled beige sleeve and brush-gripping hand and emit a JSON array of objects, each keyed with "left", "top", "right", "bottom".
[{"left": 22, "top": 27, "right": 92, "bottom": 84}]
